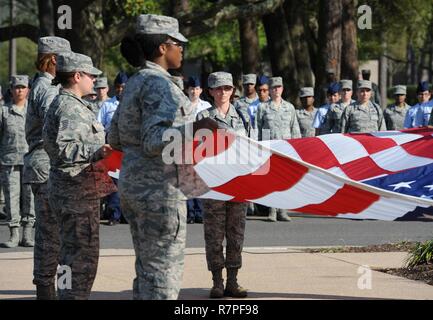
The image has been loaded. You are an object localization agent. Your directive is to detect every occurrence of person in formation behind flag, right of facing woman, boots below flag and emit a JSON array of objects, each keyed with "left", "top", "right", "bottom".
[{"left": 256, "top": 77, "right": 301, "bottom": 221}]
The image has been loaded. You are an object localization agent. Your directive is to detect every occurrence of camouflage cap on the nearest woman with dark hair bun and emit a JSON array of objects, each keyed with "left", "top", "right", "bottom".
[{"left": 135, "top": 14, "right": 188, "bottom": 42}]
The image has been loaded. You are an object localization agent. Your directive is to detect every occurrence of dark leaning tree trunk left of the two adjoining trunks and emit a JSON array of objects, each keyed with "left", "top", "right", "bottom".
[{"left": 284, "top": 0, "right": 313, "bottom": 88}]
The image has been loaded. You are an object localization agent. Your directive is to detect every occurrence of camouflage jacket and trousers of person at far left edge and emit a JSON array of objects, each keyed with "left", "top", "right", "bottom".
[{"left": 0, "top": 102, "right": 35, "bottom": 228}]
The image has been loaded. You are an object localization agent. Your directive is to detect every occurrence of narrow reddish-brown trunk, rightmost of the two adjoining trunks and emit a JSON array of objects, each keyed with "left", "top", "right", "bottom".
[{"left": 341, "top": 0, "right": 359, "bottom": 83}]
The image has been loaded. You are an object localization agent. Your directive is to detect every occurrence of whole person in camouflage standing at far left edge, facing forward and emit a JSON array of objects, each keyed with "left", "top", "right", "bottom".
[{"left": 0, "top": 75, "right": 35, "bottom": 248}]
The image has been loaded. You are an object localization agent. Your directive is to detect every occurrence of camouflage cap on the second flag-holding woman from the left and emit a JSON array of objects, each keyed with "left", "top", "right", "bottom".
[{"left": 56, "top": 52, "right": 102, "bottom": 76}]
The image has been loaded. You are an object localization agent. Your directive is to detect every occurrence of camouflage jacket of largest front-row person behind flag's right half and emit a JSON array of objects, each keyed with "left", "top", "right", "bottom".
[{"left": 341, "top": 101, "right": 385, "bottom": 133}]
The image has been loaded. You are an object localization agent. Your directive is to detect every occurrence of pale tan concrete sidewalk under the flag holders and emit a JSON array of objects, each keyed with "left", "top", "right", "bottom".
[{"left": 0, "top": 247, "right": 433, "bottom": 300}]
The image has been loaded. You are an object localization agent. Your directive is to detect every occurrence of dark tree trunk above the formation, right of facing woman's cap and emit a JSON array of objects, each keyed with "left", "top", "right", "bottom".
[{"left": 239, "top": 18, "right": 260, "bottom": 74}]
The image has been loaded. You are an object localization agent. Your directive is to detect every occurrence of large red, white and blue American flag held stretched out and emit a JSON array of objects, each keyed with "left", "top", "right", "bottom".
[{"left": 103, "top": 127, "right": 433, "bottom": 221}]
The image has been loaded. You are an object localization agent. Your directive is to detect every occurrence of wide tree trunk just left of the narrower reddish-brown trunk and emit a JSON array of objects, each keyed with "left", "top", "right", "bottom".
[{"left": 316, "top": 0, "right": 343, "bottom": 86}]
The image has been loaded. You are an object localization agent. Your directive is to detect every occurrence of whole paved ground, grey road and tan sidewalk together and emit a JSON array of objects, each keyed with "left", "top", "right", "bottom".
[{"left": 0, "top": 217, "right": 433, "bottom": 300}]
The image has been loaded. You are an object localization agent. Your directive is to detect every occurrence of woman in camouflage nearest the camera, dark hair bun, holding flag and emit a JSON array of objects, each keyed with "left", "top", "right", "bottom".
[{"left": 108, "top": 14, "right": 216, "bottom": 299}]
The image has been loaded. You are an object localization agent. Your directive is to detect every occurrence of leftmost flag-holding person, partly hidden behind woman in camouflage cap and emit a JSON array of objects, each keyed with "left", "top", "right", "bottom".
[{"left": 23, "top": 37, "right": 71, "bottom": 299}]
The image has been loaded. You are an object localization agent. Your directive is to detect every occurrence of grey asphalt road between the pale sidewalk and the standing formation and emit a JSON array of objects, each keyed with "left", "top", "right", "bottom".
[{"left": 0, "top": 216, "right": 433, "bottom": 253}]
